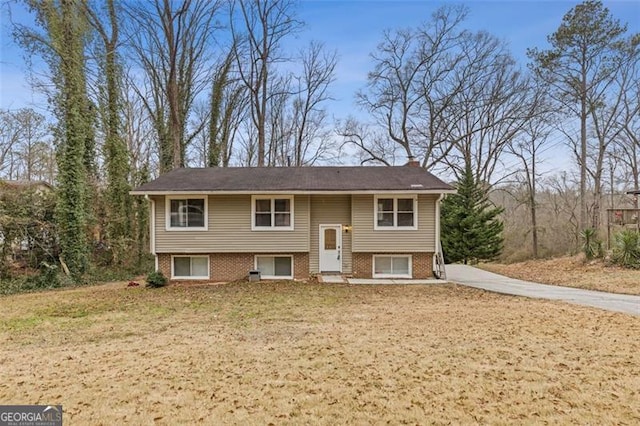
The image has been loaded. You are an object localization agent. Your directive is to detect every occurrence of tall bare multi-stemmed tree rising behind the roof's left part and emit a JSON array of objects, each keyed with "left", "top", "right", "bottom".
[{"left": 128, "top": 0, "right": 219, "bottom": 173}]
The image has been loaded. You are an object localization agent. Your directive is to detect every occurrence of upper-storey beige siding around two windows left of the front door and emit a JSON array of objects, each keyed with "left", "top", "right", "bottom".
[{"left": 154, "top": 195, "right": 309, "bottom": 253}]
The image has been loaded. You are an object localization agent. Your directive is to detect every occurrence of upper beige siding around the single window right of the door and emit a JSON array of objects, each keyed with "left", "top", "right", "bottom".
[{"left": 351, "top": 194, "right": 437, "bottom": 253}]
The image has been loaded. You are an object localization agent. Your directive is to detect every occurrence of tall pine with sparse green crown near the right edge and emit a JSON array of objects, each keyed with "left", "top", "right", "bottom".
[{"left": 527, "top": 0, "right": 627, "bottom": 230}]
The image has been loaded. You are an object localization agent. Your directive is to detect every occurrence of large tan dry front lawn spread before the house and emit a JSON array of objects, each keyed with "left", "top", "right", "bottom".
[{"left": 0, "top": 282, "right": 640, "bottom": 425}]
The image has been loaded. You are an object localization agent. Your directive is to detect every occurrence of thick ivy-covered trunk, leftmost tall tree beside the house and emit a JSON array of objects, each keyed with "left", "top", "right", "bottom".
[{"left": 16, "top": 0, "right": 96, "bottom": 282}]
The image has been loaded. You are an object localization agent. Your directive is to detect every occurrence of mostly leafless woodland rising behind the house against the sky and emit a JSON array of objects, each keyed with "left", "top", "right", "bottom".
[{"left": 0, "top": 0, "right": 640, "bottom": 279}]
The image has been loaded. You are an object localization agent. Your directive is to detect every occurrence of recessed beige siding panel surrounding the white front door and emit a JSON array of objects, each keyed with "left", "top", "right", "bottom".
[{"left": 309, "top": 195, "right": 352, "bottom": 274}]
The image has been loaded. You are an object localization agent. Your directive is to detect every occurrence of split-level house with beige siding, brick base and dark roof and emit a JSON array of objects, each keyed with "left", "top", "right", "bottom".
[{"left": 132, "top": 162, "right": 454, "bottom": 281}]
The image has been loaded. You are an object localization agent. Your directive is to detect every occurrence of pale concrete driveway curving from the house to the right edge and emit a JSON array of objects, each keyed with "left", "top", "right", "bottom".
[{"left": 446, "top": 265, "right": 640, "bottom": 315}]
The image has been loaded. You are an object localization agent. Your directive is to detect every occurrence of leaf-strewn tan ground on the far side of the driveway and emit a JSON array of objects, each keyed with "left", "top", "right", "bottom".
[{"left": 479, "top": 255, "right": 640, "bottom": 295}]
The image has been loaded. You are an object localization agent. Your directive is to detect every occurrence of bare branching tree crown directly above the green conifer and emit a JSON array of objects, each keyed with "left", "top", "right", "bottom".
[{"left": 439, "top": 32, "right": 534, "bottom": 184}]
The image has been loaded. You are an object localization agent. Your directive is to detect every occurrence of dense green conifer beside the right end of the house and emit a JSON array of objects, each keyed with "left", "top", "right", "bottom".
[{"left": 441, "top": 165, "right": 504, "bottom": 264}]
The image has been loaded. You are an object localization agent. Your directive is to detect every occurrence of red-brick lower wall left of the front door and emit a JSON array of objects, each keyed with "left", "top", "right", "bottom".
[{"left": 158, "top": 253, "right": 309, "bottom": 281}]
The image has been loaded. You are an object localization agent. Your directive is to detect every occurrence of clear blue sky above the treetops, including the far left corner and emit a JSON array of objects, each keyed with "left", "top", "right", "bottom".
[{"left": 0, "top": 0, "right": 640, "bottom": 171}]
